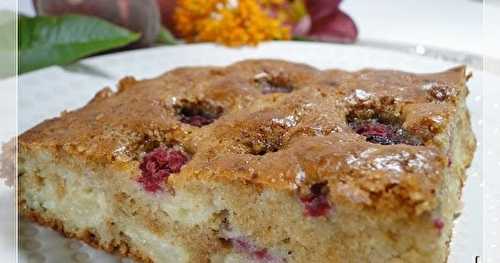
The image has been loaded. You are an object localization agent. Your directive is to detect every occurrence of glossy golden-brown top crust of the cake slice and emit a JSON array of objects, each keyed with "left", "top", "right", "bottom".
[{"left": 20, "top": 60, "right": 473, "bottom": 219}]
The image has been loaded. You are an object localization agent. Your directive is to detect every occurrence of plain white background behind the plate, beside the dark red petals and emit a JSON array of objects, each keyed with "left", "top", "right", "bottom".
[{"left": 13, "top": 0, "right": 500, "bottom": 58}]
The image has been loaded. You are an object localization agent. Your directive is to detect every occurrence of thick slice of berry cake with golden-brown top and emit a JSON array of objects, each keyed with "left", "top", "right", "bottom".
[{"left": 19, "top": 60, "right": 475, "bottom": 263}]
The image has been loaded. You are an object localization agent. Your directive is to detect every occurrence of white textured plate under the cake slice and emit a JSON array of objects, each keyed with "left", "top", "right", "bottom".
[{"left": 12, "top": 42, "right": 492, "bottom": 263}]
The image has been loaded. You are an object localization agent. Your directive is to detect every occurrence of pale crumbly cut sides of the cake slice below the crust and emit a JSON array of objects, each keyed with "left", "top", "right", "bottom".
[{"left": 19, "top": 60, "right": 475, "bottom": 262}]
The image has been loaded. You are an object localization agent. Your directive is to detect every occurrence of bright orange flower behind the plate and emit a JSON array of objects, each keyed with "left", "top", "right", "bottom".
[{"left": 174, "top": 0, "right": 291, "bottom": 46}]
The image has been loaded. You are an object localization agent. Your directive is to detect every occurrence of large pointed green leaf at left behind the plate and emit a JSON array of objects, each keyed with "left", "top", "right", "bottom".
[{"left": 18, "top": 15, "right": 140, "bottom": 73}]
